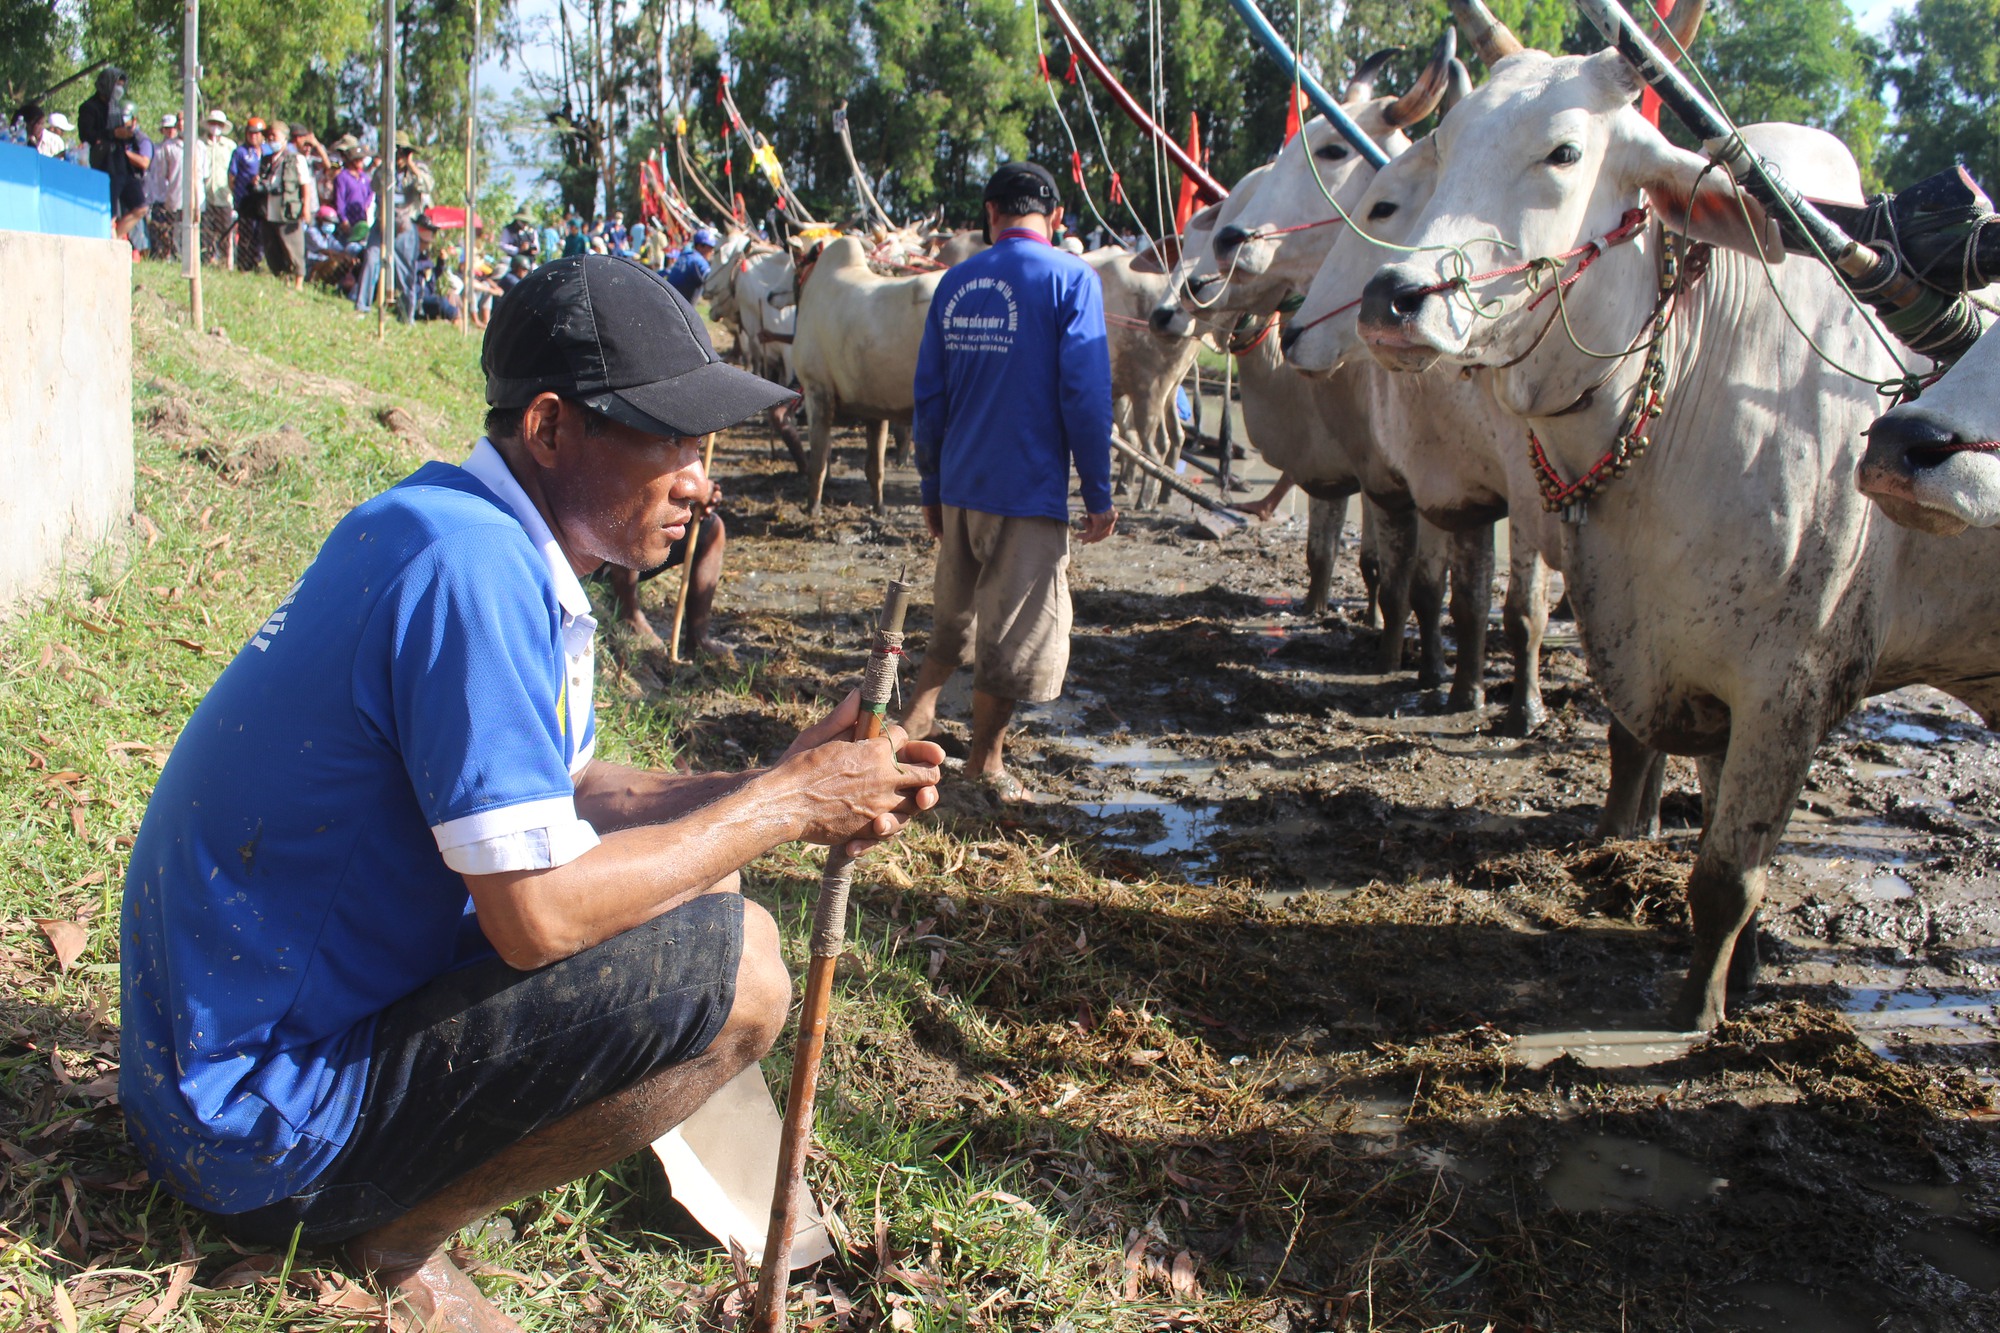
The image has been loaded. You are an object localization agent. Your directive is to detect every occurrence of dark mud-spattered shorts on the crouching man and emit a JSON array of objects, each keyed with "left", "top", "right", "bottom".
[{"left": 214, "top": 893, "right": 744, "bottom": 1249}]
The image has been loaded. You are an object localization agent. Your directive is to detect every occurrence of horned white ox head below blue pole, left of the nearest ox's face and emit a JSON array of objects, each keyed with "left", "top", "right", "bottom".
[{"left": 1210, "top": 28, "right": 1458, "bottom": 310}]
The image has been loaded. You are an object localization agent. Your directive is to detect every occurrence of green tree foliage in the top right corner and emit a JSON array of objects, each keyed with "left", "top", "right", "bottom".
[{"left": 1882, "top": 0, "right": 2000, "bottom": 190}]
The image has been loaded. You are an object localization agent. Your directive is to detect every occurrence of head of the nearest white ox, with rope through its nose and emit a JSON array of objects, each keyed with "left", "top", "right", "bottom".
[{"left": 1360, "top": 0, "right": 1782, "bottom": 370}]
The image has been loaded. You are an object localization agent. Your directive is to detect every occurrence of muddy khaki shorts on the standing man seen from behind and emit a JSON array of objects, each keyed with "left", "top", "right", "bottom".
[{"left": 924, "top": 504, "right": 1070, "bottom": 703}]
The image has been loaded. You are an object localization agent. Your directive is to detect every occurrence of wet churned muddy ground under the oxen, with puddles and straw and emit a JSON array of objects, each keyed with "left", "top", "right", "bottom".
[{"left": 624, "top": 420, "right": 2000, "bottom": 1333}]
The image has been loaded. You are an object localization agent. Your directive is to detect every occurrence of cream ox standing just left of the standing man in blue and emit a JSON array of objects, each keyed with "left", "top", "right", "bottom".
[{"left": 792, "top": 236, "right": 944, "bottom": 514}]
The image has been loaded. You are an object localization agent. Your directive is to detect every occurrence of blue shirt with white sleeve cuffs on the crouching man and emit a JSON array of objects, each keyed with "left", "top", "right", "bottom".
[{"left": 118, "top": 440, "right": 596, "bottom": 1213}]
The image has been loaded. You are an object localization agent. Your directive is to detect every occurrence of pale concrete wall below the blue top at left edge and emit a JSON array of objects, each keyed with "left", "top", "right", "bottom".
[{"left": 0, "top": 230, "right": 132, "bottom": 612}]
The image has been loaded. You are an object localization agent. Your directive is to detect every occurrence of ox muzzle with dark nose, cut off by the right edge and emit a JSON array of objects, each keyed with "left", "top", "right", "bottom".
[{"left": 1854, "top": 324, "right": 2000, "bottom": 536}]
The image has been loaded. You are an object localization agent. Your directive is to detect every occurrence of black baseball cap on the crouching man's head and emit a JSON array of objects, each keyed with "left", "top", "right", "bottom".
[{"left": 480, "top": 254, "right": 798, "bottom": 434}]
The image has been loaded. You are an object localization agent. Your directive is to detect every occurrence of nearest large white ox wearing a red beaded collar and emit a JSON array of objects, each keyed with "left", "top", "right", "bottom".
[{"left": 1360, "top": 0, "right": 2000, "bottom": 1029}]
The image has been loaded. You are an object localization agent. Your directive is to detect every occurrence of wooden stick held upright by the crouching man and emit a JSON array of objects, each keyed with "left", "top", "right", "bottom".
[{"left": 750, "top": 578, "right": 910, "bottom": 1333}]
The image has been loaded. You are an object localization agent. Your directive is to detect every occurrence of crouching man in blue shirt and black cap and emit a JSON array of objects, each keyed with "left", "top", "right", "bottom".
[{"left": 120, "top": 256, "right": 944, "bottom": 1331}]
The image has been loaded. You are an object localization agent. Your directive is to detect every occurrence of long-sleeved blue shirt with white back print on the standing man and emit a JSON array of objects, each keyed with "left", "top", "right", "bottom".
[{"left": 910, "top": 228, "right": 1112, "bottom": 522}]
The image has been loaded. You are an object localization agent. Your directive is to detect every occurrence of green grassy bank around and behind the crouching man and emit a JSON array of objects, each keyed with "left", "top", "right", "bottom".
[{"left": 0, "top": 266, "right": 1184, "bottom": 1329}]
